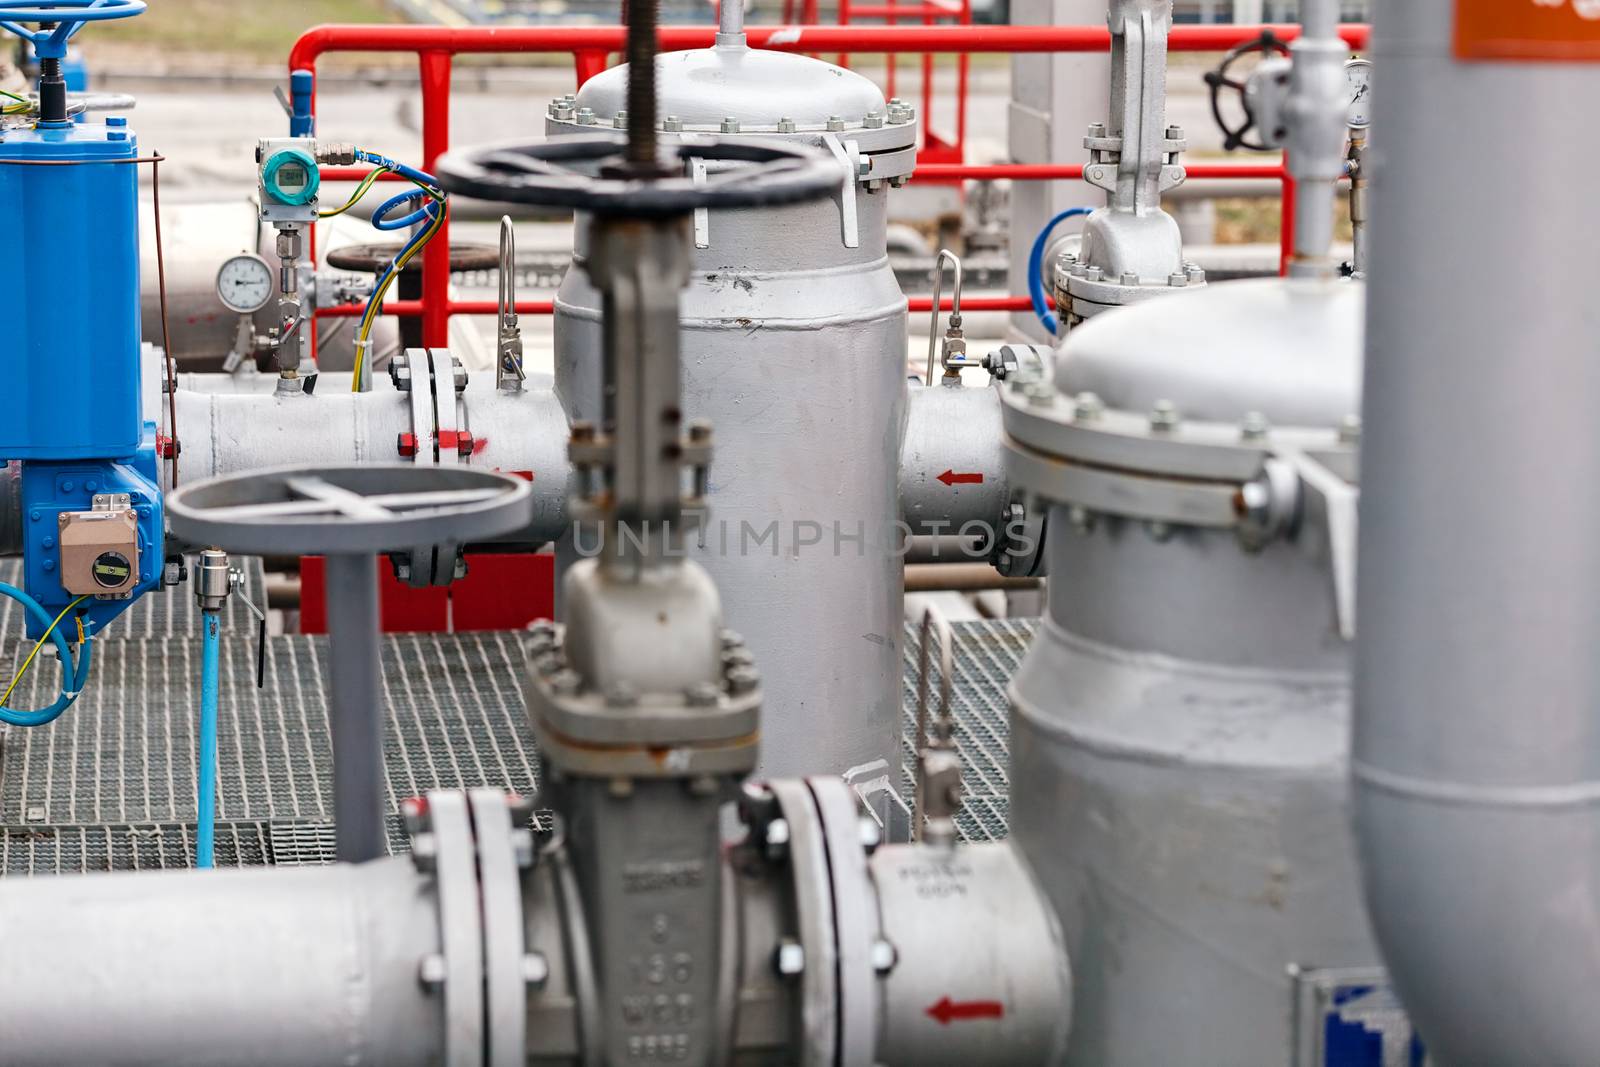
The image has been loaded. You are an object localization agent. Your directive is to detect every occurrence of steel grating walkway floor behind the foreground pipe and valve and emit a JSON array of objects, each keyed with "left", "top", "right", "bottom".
[{"left": 0, "top": 568, "right": 1032, "bottom": 873}]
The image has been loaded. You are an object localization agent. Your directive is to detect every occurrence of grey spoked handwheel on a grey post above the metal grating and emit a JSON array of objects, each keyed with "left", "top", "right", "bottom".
[{"left": 166, "top": 464, "right": 533, "bottom": 555}]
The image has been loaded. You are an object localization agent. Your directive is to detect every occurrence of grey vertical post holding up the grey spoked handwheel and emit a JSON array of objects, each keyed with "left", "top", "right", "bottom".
[{"left": 328, "top": 555, "right": 389, "bottom": 864}]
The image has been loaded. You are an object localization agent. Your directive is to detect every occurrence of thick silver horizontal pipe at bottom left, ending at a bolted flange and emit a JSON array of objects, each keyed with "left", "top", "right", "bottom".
[{"left": 0, "top": 859, "right": 443, "bottom": 1067}]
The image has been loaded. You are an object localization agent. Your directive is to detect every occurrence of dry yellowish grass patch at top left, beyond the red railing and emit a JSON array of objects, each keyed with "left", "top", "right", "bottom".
[{"left": 78, "top": 0, "right": 402, "bottom": 64}]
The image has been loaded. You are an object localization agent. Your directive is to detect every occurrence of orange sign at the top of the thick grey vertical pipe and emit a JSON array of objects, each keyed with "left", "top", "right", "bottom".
[{"left": 1459, "top": 0, "right": 1600, "bottom": 62}]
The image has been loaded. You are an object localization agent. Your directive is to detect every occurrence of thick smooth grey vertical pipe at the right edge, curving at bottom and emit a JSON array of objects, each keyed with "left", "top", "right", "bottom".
[{"left": 1354, "top": 0, "right": 1600, "bottom": 1064}]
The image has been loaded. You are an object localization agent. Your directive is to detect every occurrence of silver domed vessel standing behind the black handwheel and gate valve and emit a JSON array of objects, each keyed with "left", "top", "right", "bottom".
[{"left": 549, "top": 34, "right": 915, "bottom": 781}]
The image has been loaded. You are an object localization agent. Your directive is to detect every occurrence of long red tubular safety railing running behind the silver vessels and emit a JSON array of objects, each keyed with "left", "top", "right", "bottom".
[{"left": 290, "top": 26, "right": 1368, "bottom": 347}]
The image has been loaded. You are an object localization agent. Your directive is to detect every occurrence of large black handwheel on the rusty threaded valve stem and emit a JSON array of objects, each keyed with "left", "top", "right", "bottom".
[{"left": 437, "top": 136, "right": 845, "bottom": 218}]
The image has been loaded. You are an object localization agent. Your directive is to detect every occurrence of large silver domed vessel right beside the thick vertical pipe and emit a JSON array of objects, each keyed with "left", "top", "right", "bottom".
[{"left": 1006, "top": 280, "right": 1379, "bottom": 1067}]
